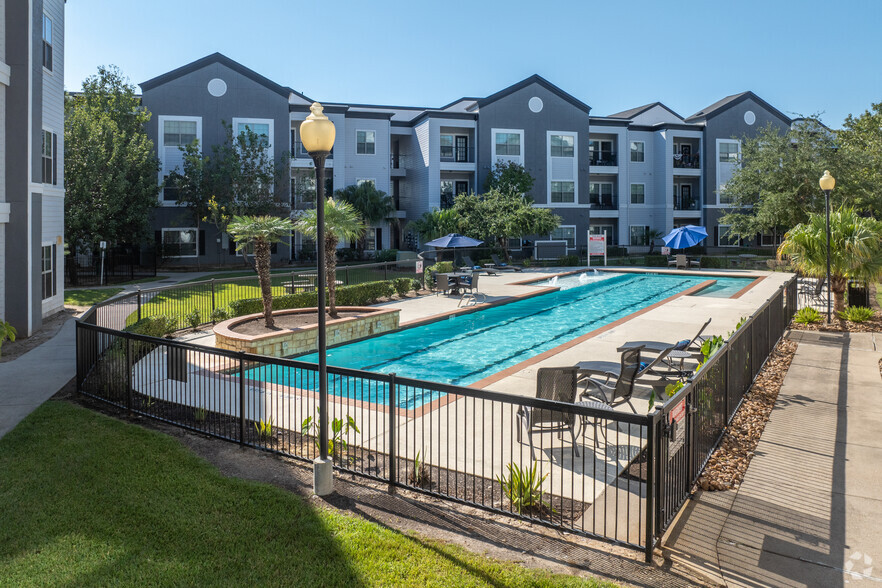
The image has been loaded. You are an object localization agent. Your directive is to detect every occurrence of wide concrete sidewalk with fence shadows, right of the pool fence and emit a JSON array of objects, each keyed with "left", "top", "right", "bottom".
[{"left": 664, "top": 331, "right": 882, "bottom": 587}]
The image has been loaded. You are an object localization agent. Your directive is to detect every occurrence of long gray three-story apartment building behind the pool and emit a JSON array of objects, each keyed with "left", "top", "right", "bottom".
[{"left": 141, "top": 53, "right": 793, "bottom": 263}]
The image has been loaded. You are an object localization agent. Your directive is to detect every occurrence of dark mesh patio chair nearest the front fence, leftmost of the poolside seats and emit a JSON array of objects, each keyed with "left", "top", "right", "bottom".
[{"left": 516, "top": 367, "right": 579, "bottom": 459}]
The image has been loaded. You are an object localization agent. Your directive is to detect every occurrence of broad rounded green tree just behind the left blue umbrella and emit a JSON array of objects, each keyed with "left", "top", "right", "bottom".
[{"left": 452, "top": 189, "right": 560, "bottom": 259}]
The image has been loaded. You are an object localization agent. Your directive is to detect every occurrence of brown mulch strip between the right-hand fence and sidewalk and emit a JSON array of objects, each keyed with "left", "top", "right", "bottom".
[{"left": 698, "top": 339, "right": 797, "bottom": 490}]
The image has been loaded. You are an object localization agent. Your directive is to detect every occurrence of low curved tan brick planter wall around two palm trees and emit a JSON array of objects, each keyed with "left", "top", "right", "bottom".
[{"left": 214, "top": 306, "right": 398, "bottom": 357}]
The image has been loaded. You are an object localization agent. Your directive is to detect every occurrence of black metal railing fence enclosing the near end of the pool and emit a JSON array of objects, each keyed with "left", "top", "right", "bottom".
[{"left": 76, "top": 272, "right": 796, "bottom": 559}]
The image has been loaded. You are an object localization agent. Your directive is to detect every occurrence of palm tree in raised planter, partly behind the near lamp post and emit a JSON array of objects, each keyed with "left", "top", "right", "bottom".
[{"left": 294, "top": 198, "right": 365, "bottom": 318}]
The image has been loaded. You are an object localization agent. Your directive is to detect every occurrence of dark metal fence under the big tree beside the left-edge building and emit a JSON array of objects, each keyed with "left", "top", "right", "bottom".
[{"left": 64, "top": 247, "right": 156, "bottom": 287}]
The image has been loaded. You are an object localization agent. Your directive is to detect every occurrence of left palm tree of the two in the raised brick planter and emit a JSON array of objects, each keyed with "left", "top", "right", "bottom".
[{"left": 227, "top": 216, "right": 294, "bottom": 329}]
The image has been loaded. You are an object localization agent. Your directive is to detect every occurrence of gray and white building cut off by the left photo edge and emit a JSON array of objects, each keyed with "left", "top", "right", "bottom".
[{"left": 0, "top": 0, "right": 64, "bottom": 337}]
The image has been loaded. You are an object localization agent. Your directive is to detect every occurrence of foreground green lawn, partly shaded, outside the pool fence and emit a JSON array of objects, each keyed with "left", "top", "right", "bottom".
[{"left": 0, "top": 401, "right": 612, "bottom": 587}]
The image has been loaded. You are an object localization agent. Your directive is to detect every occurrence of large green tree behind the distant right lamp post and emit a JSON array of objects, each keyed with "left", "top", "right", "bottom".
[{"left": 720, "top": 118, "right": 862, "bottom": 238}]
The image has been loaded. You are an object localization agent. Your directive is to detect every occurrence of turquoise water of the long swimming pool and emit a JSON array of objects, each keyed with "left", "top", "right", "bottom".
[{"left": 248, "top": 274, "right": 750, "bottom": 408}]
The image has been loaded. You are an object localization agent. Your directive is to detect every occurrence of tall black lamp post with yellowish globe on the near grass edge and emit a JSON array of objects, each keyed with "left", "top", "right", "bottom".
[{"left": 300, "top": 102, "right": 336, "bottom": 496}]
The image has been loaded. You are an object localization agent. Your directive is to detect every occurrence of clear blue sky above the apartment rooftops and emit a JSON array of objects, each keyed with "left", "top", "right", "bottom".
[{"left": 64, "top": 0, "right": 882, "bottom": 128}]
